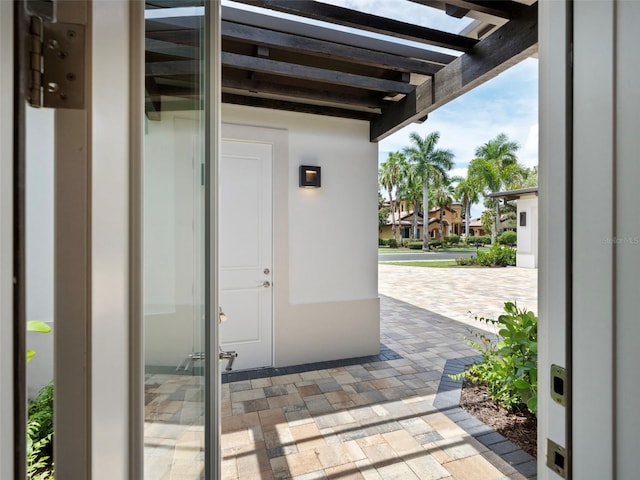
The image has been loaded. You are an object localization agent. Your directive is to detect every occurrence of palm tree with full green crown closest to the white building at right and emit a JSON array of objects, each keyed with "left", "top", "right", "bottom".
[{"left": 469, "top": 133, "right": 522, "bottom": 243}]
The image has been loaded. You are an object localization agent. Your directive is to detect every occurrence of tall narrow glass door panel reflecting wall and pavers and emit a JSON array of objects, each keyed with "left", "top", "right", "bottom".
[{"left": 143, "top": 0, "right": 207, "bottom": 480}]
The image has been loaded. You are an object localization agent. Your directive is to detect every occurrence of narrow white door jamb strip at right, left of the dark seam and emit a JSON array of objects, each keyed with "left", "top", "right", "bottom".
[{"left": 538, "top": 1, "right": 571, "bottom": 479}]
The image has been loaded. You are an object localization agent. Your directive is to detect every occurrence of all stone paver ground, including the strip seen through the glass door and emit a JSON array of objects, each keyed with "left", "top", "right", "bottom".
[{"left": 145, "top": 265, "right": 537, "bottom": 480}]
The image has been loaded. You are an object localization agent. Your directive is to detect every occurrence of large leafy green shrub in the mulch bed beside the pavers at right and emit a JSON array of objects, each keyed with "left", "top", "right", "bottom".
[{"left": 453, "top": 302, "right": 538, "bottom": 413}]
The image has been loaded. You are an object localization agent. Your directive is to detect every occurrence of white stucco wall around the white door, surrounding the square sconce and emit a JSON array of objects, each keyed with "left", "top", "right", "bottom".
[{"left": 222, "top": 105, "right": 380, "bottom": 366}]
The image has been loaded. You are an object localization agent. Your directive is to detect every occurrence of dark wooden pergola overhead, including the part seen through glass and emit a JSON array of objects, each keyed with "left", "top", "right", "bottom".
[{"left": 146, "top": 0, "right": 538, "bottom": 141}]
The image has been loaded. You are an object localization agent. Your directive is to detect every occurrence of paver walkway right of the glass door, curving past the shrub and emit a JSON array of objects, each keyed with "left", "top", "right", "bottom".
[{"left": 222, "top": 265, "right": 536, "bottom": 480}]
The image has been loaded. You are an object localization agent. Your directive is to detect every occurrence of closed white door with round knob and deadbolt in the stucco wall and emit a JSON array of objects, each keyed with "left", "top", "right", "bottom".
[{"left": 219, "top": 140, "right": 273, "bottom": 370}]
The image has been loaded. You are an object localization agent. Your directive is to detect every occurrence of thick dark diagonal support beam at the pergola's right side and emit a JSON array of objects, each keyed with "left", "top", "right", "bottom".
[{"left": 370, "top": 3, "right": 538, "bottom": 142}]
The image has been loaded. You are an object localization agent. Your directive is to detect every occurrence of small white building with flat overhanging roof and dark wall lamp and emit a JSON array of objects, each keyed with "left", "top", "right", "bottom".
[{"left": 489, "top": 187, "right": 538, "bottom": 268}]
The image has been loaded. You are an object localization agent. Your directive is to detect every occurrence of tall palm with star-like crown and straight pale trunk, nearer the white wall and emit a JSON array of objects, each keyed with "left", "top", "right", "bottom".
[{"left": 403, "top": 132, "right": 453, "bottom": 250}]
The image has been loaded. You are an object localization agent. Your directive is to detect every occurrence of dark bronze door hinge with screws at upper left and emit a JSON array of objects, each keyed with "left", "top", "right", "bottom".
[{"left": 26, "top": 17, "right": 85, "bottom": 109}]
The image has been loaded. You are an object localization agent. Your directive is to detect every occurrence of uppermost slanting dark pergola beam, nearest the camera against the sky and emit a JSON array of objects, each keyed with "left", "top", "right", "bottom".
[{"left": 232, "top": 0, "right": 477, "bottom": 51}]
